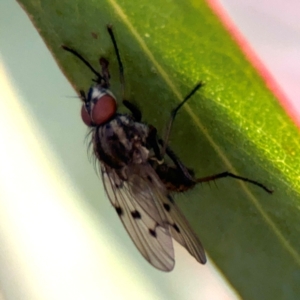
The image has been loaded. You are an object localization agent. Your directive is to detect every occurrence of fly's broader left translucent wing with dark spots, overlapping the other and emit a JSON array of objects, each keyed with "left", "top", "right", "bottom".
[{"left": 101, "top": 164, "right": 175, "bottom": 271}]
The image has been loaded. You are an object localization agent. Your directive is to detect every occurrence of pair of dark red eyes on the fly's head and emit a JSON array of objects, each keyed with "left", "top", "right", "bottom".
[{"left": 81, "top": 94, "right": 117, "bottom": 126}]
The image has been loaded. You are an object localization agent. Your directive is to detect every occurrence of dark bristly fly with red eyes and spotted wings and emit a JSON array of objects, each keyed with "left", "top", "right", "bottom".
[{"left": 62, "top": 25, "right": 272, "bottom": 271}]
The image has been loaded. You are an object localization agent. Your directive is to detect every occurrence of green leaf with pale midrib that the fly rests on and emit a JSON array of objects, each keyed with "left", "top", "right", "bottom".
[{"left": 19, "top": 0, "right": 300, "bottom": 300}]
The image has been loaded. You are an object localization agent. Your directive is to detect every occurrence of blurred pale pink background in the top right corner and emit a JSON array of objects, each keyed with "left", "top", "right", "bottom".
[{"left": 217, "top": 0, "right": 300, "bottom": 124}]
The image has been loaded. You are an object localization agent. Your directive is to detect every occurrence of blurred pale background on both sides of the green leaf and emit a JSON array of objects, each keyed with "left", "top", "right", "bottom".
[{"left": 0, "top": 0, "right": 300, "bottom": 300}]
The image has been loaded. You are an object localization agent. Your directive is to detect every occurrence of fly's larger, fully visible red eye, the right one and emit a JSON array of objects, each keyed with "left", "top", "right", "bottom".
[{"left": 91, "top": 94, "right": 117, "bottom": 125}]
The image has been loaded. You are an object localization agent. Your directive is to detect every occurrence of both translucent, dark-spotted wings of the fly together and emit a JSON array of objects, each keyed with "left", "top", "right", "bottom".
[{"left": 101, "top": 163, "right": 206, "bottom": 271}]
